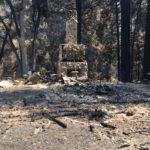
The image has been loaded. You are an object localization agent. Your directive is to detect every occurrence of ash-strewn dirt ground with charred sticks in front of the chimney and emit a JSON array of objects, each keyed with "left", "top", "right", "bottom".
[{"left": 0, "top": 82, "right": 150, "bottom": 150}]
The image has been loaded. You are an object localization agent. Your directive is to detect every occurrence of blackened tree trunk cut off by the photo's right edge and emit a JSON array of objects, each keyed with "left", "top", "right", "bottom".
[{"left": 143, "top": 0, "right": 150, "bottom": 79}]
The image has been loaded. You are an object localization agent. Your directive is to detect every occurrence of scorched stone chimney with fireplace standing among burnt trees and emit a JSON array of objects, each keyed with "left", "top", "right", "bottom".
[{"left": 58, "top": 1, "right": 88, "bottom": 80}]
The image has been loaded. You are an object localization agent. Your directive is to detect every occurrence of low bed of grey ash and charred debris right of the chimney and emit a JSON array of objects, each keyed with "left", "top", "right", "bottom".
[{"left": 61, "top": 83, "right": 150, "bottom": 105}]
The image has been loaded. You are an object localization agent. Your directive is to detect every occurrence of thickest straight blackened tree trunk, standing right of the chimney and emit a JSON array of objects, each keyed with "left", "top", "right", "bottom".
[{"left": 121, "top": 0, "right": 131, "bottom": 82}]
